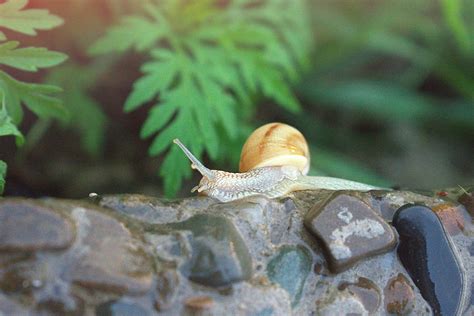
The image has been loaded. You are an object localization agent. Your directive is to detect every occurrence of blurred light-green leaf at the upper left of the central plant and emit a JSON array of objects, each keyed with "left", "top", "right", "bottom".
[{"left": 89, "top": 16, "right": 164, "bottom": 55}]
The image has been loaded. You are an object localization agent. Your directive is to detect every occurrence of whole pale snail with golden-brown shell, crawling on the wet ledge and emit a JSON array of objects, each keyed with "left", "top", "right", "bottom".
[{"left": 173, "top": 123, "right": 382, "bottom": 202}]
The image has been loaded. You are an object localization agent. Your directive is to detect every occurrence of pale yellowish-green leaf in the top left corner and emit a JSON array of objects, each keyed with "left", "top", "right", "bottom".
[{"left": 0, "top": 0, "right": 63, "bottom": 35}]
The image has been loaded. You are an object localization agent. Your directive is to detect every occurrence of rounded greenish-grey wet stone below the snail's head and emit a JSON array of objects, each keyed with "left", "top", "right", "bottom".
[{"left": 168, "top": 214, "right": 252, "bottom": 286}]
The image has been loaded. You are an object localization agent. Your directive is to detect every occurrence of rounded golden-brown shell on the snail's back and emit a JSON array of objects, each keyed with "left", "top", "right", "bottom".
[{"left": 239, "top": 123, "right": 310, "bottom": 175}]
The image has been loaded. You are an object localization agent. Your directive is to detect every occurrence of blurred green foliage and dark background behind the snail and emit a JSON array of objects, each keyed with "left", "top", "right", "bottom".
[{"left": 0, "top": 0, "right": 474, "bottom": 197}]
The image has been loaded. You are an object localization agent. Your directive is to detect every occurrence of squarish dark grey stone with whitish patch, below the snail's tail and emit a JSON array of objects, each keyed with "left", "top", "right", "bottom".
[{"left": 305, "top": 193, "right": 396, "bottom": 272}]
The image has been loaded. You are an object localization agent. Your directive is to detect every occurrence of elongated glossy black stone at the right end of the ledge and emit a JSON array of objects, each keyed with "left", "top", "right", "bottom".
[{"left": 392, "top": 204, "right": 464, "bottom": 315}]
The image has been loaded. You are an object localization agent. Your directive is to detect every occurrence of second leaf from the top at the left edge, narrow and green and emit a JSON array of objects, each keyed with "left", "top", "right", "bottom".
[{"left": 0, "top": 41, "right": 67, "bottom": 71}]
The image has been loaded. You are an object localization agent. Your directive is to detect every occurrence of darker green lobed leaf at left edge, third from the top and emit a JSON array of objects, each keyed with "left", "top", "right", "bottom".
[{"left": 0, "top": 71, "right": 68, "bottom": 124}]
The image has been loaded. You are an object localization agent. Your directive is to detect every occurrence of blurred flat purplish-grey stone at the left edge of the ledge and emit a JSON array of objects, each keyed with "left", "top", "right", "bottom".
[{"left": 0, "top": 199, "right": 75, "bottom": 251}]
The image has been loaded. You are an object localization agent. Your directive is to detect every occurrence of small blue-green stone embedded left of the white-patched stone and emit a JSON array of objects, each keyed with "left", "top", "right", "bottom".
[{"left": 267, "top": 246, "right": 313, "bottom": 306}]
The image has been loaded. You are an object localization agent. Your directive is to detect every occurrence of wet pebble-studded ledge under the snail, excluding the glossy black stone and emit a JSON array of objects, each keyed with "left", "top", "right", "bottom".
[{"left": 0, "top": 191, "right": 474, "bottom": 316}]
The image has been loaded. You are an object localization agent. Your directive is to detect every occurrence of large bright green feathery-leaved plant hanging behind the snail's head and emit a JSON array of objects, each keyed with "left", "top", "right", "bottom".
[{"left": 90, "top": 0, "right": 311, "bottom": 195}]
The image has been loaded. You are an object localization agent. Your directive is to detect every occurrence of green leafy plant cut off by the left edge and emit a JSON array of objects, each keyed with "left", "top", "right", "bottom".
[{"left": 0, "top": 0, "right": 68, "bottom": 191}]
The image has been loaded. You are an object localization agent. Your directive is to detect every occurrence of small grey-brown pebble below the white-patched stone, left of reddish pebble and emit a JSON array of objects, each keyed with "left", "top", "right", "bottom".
[{"left": 338, "top": 277, "right": 380, "bottom": 314}]
